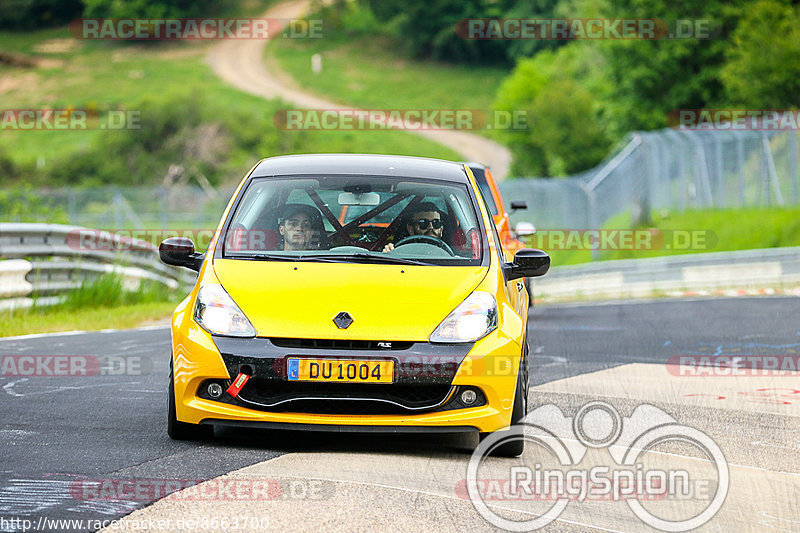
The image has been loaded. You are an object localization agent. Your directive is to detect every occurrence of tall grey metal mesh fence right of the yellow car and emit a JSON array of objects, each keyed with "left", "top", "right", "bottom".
[{"left": 500, "top": 129, "right": 800, "bottom": 229}]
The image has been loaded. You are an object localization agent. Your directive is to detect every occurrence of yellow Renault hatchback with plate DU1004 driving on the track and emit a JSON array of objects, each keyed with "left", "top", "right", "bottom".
[{"left": 160, "top": 154, "right": 550, "bottom": 455}]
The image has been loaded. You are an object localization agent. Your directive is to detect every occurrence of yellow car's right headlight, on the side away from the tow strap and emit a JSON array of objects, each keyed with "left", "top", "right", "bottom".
[{"left": 429, "top": 291, "right": 497, "bottom": 342}]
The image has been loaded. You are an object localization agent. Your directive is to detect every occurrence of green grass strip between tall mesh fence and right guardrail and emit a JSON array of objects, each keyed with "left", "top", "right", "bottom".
[{"left": 528, "top": 207, "right": 800, "bottom": 266}]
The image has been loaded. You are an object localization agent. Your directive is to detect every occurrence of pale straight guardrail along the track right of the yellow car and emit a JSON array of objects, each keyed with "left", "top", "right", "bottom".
[{"left": 534, "top": 247, "right": 800, "bottom": 301}]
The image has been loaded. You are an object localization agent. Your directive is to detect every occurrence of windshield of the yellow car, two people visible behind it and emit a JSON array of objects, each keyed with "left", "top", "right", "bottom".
[{"left": 223, "top": 176, "right": 486, "bottom": 265}]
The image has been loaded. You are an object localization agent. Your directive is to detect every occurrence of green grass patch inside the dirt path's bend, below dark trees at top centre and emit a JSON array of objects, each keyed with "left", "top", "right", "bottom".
[{"left": 266, "top": 32, "right": 508, "bottom": 133}]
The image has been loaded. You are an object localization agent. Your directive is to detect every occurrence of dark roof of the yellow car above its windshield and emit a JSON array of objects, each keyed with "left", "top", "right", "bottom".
[{"left": 250, "top": 154, "right": 468, "bottom": 183}]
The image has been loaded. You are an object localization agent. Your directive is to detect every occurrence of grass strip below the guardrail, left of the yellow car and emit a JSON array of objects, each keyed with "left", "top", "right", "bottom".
[{"left": 0, "top": 302, "right": 176, "bottom": 337}]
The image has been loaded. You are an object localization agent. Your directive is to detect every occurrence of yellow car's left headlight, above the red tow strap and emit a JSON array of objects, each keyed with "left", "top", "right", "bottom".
[{"left": 194, "top": 284, "right": 256, "bottom": 337}]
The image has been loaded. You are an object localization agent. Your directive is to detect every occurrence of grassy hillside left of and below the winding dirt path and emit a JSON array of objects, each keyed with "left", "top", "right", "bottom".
[{"left": 0, "top": 25, "right": 457, "bottom": 178}]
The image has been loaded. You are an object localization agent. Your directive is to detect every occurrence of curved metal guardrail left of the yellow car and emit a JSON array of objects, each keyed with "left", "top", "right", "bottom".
[{"left": 0, "top": 223, "right": 196, "bottom": 309}]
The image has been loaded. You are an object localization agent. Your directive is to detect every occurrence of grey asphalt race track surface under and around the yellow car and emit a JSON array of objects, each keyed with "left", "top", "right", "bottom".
[{"left": 0, "top": 297, "right": 800, "bottom": 531}]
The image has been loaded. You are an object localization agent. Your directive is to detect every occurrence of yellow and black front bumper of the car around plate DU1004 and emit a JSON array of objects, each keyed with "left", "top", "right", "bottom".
[{"left": 173, "top": 319, "right": 521, "bottom": 432}]
